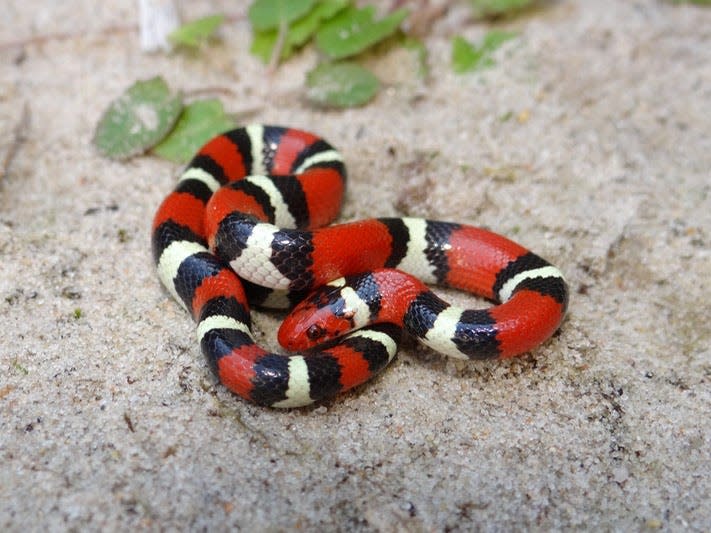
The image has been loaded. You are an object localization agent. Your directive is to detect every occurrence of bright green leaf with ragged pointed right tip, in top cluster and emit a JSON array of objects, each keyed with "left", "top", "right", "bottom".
[{"left": 316, "top": 6, "right": 408, "bottom": 59}]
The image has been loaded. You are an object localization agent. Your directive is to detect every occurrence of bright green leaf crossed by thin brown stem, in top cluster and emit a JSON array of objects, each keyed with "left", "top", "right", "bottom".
[{"left": 250, "top": 0, "right": 350, "bottom": 63}]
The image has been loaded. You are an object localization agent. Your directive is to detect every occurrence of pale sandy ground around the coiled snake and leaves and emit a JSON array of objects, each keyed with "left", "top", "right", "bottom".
[{"left": 0, "top": 0, "right": 711, "bottom": 531}]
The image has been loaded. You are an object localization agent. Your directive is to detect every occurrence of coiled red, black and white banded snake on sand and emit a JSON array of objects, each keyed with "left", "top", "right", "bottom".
[{"left": 152, "top": 124, "right": 568, "bottom": 407}]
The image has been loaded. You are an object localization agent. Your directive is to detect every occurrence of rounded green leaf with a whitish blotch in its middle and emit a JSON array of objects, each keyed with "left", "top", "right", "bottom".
[{"left": 93, "top": 76, "right": 183, "bottom": 159}]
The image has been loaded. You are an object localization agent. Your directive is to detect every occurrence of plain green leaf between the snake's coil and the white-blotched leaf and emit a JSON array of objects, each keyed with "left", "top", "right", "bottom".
[{"left": 153, "top": 99, "right": 236, "bottom": 163}]
